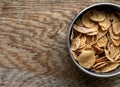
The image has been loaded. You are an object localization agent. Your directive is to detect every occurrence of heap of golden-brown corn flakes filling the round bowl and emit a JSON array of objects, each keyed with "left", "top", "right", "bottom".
[{"left": 70, "top": 9, "right": 120, "bottom": 73}]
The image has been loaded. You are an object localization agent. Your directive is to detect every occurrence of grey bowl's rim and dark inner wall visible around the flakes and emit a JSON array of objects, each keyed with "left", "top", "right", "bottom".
[{"left": 67, "top": 3, "right": 120, "bottom": 77}]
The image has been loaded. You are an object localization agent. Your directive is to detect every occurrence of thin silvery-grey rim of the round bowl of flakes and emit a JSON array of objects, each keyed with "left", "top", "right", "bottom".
[{"left": 67, "top": 3, "right": 120, "bottom": 77}]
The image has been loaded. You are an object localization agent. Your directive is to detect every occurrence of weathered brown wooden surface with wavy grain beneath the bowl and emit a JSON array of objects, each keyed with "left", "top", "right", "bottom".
[{"left": 0, "top": 0, "right": 120, "bottom": 87}]
